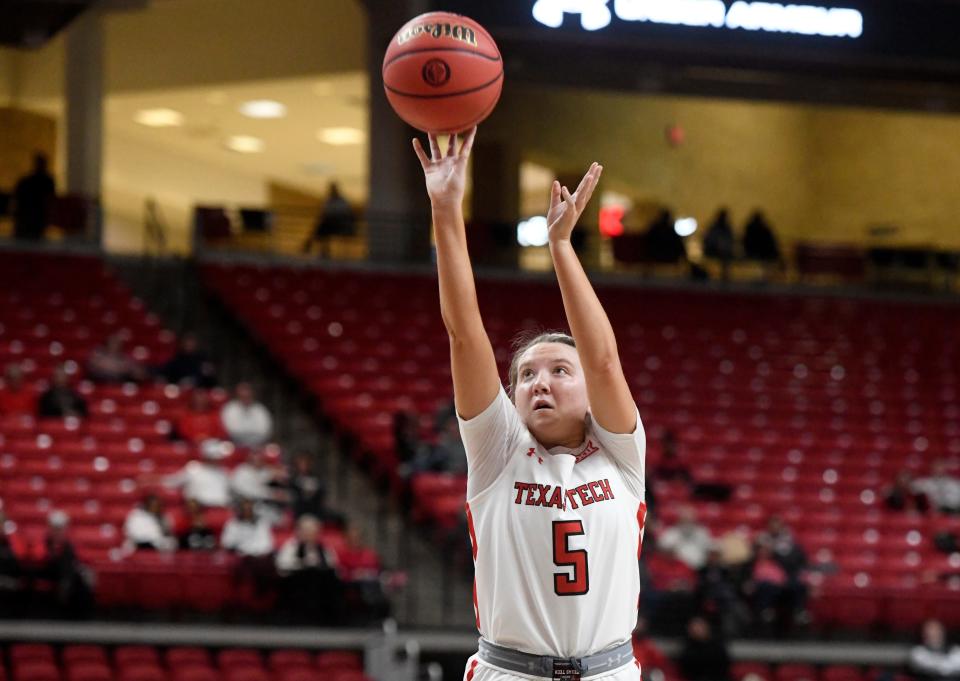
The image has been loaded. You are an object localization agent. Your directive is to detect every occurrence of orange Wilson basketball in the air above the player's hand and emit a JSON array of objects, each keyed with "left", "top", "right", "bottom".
[{"left": 383, "top": 12, "right": 503, "bottom": 134}]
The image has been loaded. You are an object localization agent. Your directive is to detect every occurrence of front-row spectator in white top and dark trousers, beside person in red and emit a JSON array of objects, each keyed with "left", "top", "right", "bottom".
[{"left": 276, "top": 515, "right": 343, "bottom": 623}]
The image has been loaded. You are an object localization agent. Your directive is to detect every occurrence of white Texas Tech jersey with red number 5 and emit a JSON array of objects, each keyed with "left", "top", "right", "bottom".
[{"left": 460, "top": 388, "right": 646, "bottom": 657}]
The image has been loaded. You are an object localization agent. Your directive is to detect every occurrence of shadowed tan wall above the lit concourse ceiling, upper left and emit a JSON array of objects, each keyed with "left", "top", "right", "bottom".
[{"left": 15, "top": 0, "right": 366, "bottom": 99}]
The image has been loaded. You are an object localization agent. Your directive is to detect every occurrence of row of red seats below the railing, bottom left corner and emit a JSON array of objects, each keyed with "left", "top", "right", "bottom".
[{"left": 0, "top": 643, "right": 369, "bottom": 681}]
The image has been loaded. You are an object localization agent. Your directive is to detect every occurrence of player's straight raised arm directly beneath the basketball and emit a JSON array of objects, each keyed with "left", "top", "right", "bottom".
[{"left": 413, "top": 128, "right": 501, "bottom": 420}]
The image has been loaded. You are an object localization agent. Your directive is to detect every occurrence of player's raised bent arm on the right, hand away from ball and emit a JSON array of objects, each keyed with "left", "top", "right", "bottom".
[{"left": 547, "top": 163, "right": 639, "bottom": 434}]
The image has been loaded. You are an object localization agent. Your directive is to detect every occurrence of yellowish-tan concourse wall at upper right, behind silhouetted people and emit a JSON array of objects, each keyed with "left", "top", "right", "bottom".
[{"left": 492, "top": 86, "right": 960, "bottom": 248}]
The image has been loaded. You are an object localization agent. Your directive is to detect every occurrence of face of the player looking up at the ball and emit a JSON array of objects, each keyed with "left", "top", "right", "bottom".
[{"left": 514, "top": 343, "right": 589, "bottom": 447}]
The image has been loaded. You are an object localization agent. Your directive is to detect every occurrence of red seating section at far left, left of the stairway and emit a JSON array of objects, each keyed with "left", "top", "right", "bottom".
[{"left": 0, "top": 253, "right": 379, "bottom": 612}]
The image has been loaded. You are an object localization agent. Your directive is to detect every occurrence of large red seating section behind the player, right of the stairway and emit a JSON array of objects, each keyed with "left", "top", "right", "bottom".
[{"left": 204, "top": 265, "right": 960, "bottom": 630}]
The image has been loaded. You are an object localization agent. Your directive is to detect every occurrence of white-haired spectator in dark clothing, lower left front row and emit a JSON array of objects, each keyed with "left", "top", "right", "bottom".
[{"left": 34, "top": 511, "right": 93, "bottom": 617}]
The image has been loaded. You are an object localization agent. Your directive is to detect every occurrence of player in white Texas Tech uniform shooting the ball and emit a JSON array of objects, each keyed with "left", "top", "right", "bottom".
[{"left": 413, "top": 128, "right": 646, "bottom": 681}]
